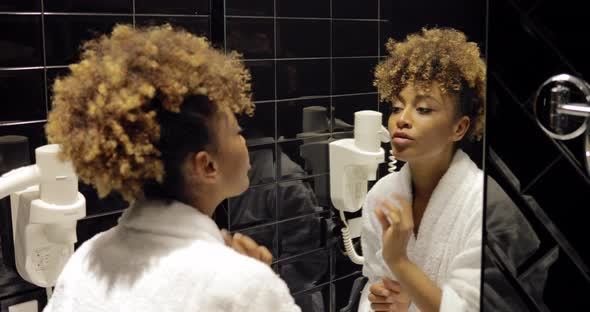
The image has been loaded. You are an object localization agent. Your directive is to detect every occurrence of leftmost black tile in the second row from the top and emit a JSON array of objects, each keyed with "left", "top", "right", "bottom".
[{"left": 0, "top": 15, "right": 43, "bottom": 67}]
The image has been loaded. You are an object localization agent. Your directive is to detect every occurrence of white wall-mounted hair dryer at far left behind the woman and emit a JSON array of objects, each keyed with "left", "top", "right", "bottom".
[{"left": 0, "top": 144, "right": 86, "bottom": 287}]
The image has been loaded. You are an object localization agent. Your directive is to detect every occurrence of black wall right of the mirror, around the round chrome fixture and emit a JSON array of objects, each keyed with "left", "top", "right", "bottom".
[{"left": 484, "top": 0, "right": 590, "bottom": 311}]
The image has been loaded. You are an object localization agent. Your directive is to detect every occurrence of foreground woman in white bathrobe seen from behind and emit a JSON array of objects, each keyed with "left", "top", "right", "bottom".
[{"left": 45, "top": 26, "right": 300, "bottom": 312}]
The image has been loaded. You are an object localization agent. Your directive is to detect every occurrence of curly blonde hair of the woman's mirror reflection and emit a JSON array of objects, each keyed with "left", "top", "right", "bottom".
[{"left": 373, "top": 28, "right": 486, "bottom": 141}]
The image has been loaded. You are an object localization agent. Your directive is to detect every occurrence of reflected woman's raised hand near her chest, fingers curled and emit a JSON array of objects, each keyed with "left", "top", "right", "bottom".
[{"left": 375, "top": 194, "right": 414, "bottom": 274}]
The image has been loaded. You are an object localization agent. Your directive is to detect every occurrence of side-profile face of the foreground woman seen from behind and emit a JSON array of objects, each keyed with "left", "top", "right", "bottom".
[{"left": 216, "top": 111, "right": 250, "bottom": 197}]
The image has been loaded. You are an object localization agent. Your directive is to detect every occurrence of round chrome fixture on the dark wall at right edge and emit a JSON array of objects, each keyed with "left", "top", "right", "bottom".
[{"left": 533, "top": 74, "right": 590, "bottom": 174}]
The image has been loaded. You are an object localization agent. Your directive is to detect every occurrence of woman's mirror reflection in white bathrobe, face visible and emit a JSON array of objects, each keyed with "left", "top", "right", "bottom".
[{"left": 359, "top": 29, "right": 485, "bottom": 311}]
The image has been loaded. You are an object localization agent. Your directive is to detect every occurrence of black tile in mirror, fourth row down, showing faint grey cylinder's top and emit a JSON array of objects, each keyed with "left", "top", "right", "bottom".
[{"left": 277, "top": 98, "right": 330, "bottom": 139}]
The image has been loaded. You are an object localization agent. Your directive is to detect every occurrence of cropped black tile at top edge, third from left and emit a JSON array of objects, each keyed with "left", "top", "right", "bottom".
[{"left": 135, "top": 0, "right": 210, "bottom": 15}]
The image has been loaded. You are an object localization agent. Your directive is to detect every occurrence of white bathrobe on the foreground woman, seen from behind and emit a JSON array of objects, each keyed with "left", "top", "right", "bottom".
[{"left": 44, "top": 201, "right": 300, "bottom": 312}]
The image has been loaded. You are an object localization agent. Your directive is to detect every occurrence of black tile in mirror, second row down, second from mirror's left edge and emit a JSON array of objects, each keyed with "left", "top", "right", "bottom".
[{"left": 277, "top": 19, "right": 330, "bottom": 58}]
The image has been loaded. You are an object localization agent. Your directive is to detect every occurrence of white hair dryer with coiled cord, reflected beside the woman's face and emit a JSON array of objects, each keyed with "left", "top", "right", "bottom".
[{"left": 329, "top": 110, "right": 391, "bottom": 264}]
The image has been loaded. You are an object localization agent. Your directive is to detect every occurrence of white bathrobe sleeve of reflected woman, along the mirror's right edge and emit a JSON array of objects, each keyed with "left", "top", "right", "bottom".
[{"left": 440, "top": 199, "right": 483, "bottom": 312}]
